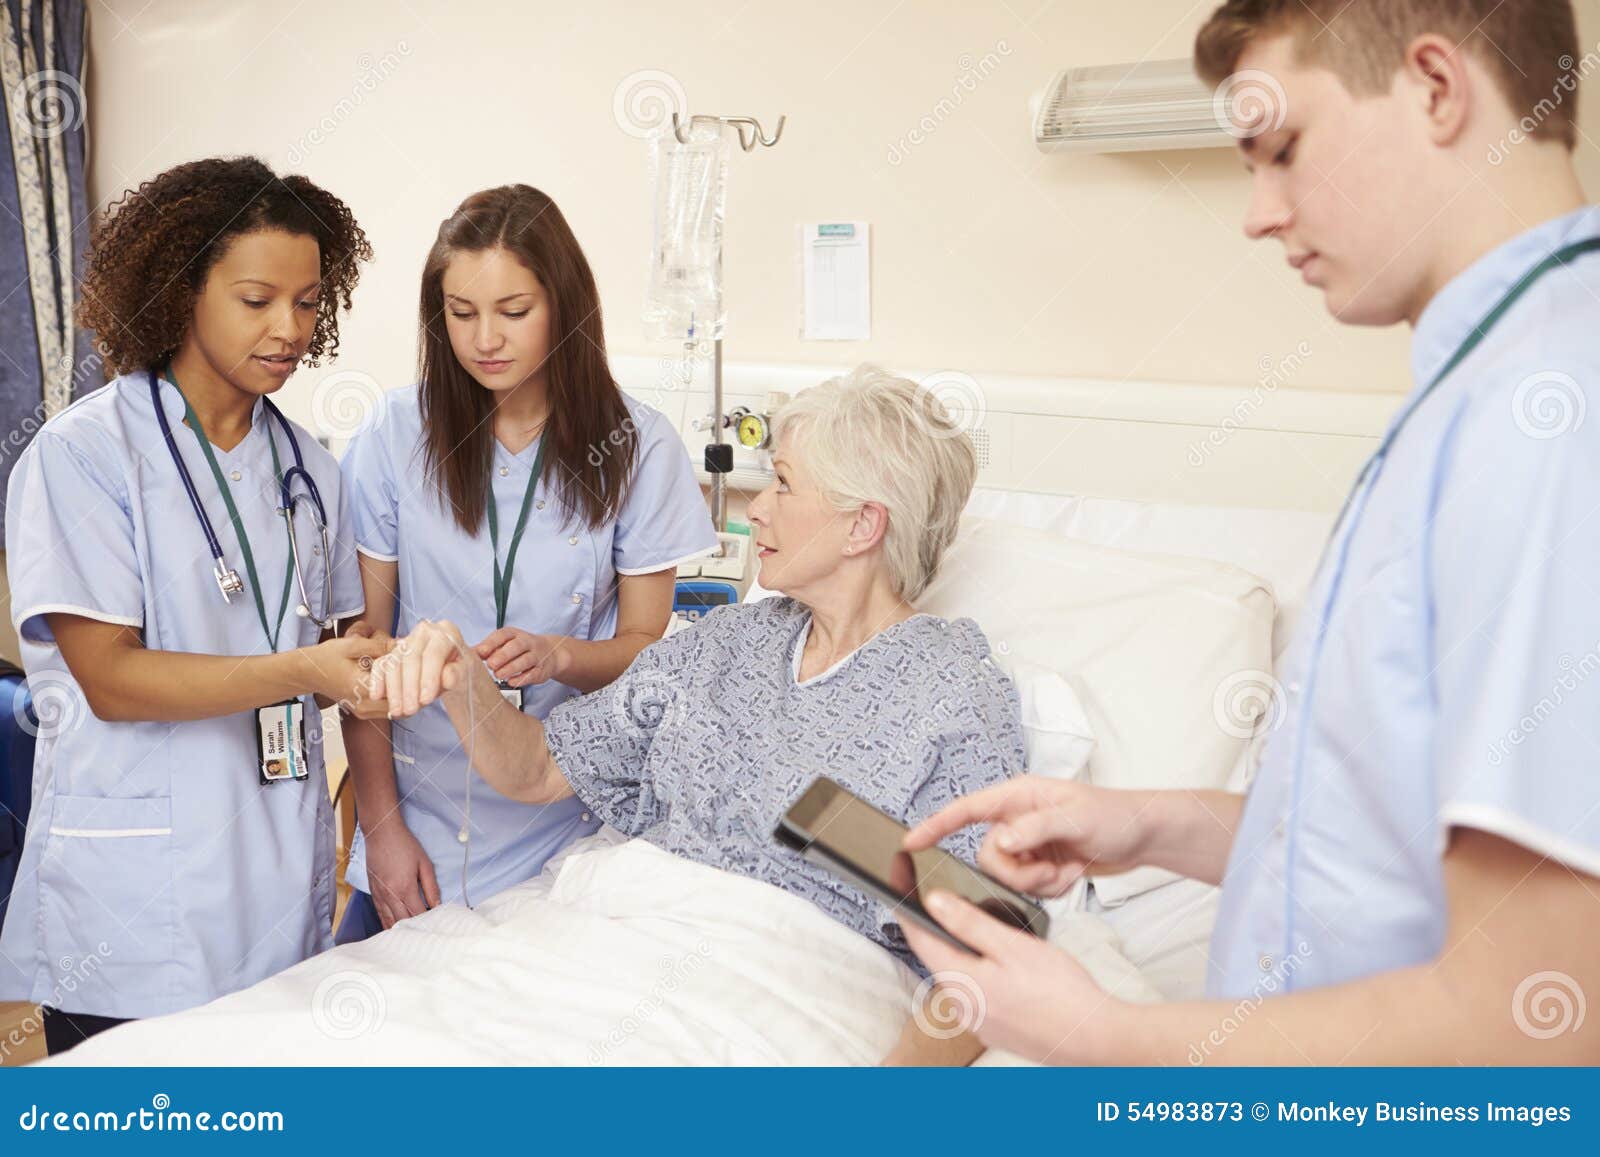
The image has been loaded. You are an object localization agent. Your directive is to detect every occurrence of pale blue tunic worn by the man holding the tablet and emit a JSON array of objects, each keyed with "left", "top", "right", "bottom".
[{"left": 1210, "top": 208, "right": 1600, "bottom": 997}]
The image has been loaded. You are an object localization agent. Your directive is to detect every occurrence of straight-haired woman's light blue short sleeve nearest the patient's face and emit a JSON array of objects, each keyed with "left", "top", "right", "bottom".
[{"left": 611, "top": 405, "right": 717, "bottom": 574}]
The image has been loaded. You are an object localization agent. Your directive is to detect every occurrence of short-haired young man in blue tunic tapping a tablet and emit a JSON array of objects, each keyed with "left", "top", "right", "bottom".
[{"left": 906, "top": 0, "right": 1600, "bottom": 1064}]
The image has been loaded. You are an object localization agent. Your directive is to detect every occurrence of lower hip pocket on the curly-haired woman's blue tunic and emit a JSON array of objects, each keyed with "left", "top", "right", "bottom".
[{"left": 38, "top": 795, "right": 176, "bottom": 965}]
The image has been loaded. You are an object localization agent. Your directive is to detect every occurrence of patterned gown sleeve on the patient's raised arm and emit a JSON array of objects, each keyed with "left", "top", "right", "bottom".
[{"left": 544, "top": 627, "right": 701, "bottom": 835}]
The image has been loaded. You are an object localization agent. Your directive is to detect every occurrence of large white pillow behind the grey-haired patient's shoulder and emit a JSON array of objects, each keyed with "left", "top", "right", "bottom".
[{"left": 920, "top": 518, "right": 1275, "bottom": 904}]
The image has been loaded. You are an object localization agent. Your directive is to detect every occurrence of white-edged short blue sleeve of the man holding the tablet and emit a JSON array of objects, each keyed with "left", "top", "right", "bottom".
[{"left": 1433, "top": 382, "right": 1600, "bottom": 874}]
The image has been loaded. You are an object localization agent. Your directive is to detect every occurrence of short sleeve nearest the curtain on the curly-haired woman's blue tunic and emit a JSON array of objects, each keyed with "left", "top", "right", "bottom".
[{"left": 6, "top": 429, "right": 144, "bottom": 643}]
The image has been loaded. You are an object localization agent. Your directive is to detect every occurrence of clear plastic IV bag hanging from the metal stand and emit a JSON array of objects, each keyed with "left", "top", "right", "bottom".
[{"left": 645, "top": 123, "right": 730, "bottom": 341}]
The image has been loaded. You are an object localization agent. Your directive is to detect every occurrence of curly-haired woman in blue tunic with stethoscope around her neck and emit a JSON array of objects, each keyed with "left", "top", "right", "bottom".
[{"left": 0, "top": 158, "right": 382, "bottom": 1053}]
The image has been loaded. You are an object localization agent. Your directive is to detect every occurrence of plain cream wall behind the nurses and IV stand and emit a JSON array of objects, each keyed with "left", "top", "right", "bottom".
[{"left": 78, "top": 0, "right": 1600, "bottom": 410}]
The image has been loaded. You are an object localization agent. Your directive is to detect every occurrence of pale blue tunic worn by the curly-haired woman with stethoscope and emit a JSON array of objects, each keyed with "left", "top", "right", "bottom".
[{"left": 0, "top": 371, "right": 362, "bottom": 1016}]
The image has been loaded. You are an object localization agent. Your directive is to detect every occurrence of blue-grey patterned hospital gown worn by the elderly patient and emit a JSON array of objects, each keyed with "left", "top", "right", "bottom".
[{"left": 546, "top": 599, "right": 1024, "bottom": 971}]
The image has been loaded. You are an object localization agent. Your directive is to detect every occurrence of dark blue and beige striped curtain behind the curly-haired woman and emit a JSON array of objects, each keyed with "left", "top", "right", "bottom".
[{"left": 0, "top": 0, "right": 92, "bottom": 544}]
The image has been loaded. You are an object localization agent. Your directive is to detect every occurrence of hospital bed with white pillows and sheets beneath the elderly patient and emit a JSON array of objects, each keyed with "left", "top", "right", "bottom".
[{"left": 53, "top": 358, "right": 1392, "bottom": 1064}]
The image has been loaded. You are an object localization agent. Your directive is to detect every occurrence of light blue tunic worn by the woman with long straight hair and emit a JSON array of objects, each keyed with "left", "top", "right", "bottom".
[{"left": 342, "top": 386, "right": 717, "bottom": 903}]
